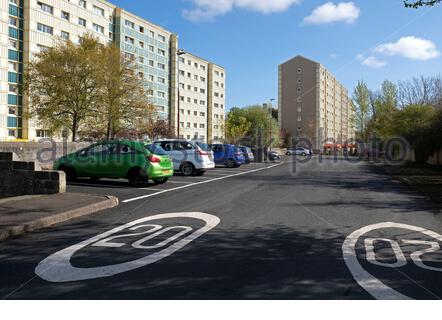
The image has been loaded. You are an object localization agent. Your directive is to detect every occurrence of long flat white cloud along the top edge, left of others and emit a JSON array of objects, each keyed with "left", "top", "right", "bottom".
[{"left": 183, "top": 0, "right": 301, "bottom": 21}]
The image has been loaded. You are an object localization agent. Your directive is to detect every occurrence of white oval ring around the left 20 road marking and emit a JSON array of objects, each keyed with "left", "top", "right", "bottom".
[{"left": 35, "top": 212, "right": 220, "bottom": 282}]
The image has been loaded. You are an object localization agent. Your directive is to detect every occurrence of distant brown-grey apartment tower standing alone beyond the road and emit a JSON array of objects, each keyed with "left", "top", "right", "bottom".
[{"left": 279, "top": 56, "right": 355, "bottom": 150}]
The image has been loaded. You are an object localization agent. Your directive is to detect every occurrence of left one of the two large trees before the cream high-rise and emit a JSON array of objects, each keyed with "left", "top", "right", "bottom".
[{"left": 24, "top": 34, "right": 101, "bottom": 141}]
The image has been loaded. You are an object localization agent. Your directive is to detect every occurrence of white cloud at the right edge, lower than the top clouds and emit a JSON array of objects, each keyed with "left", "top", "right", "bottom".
[{"left": 375, "top": 36, "right": 440, "bottom": 60}]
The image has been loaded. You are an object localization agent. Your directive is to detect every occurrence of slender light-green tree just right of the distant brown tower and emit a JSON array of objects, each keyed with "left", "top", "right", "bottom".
[{"left": 353, "top": 81, "right": 370, "bottom": 137}]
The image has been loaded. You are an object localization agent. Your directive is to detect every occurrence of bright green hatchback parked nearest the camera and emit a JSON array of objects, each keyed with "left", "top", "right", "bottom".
[{"left": 54, "top": 140, "right": 173, "bottom": 187}]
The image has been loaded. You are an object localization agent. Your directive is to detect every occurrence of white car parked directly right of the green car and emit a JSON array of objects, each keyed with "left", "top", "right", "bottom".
[{"left": 153, "top": 139, "right": 215, "bottom": 176}]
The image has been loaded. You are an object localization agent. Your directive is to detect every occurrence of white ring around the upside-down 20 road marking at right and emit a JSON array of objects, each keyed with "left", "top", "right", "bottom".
[{"left": 342, "top": 222, "right": 442, "bottom": 300}]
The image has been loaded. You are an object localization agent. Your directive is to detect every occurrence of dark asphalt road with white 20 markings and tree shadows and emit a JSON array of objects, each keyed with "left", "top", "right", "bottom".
[{"left": 0, "top": 158, "right": 442, "bottom": 299}]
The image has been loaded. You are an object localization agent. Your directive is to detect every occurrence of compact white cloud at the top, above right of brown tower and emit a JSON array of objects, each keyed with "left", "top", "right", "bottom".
[{"left": 304, "top": 2, "right": 361, "bottom": 24}]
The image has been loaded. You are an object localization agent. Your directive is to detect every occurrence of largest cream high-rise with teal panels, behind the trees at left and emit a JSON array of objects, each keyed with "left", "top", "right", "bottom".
[{"left": 0, "top": 0, "right": 225, "bottom": 141}]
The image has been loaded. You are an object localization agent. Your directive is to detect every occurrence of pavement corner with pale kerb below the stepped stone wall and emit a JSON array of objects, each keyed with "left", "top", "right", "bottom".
[{"left": 0, "top": 193, "right": 118, "bottom": 241}]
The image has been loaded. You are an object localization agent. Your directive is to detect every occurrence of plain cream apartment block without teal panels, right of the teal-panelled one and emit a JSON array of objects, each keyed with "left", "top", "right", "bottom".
[{"left": 176, "top": 53, "right": 225, "bottom": 141}]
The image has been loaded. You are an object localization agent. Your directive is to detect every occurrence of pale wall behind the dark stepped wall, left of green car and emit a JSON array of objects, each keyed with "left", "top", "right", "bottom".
[{"left": 0, "top": 141, "right": 90, "bottom": 170}]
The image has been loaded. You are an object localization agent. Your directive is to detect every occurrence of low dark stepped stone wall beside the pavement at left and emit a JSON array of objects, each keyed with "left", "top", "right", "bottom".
[{"left": 0, "top": 152, "right": 66, "bottom": 198}]
